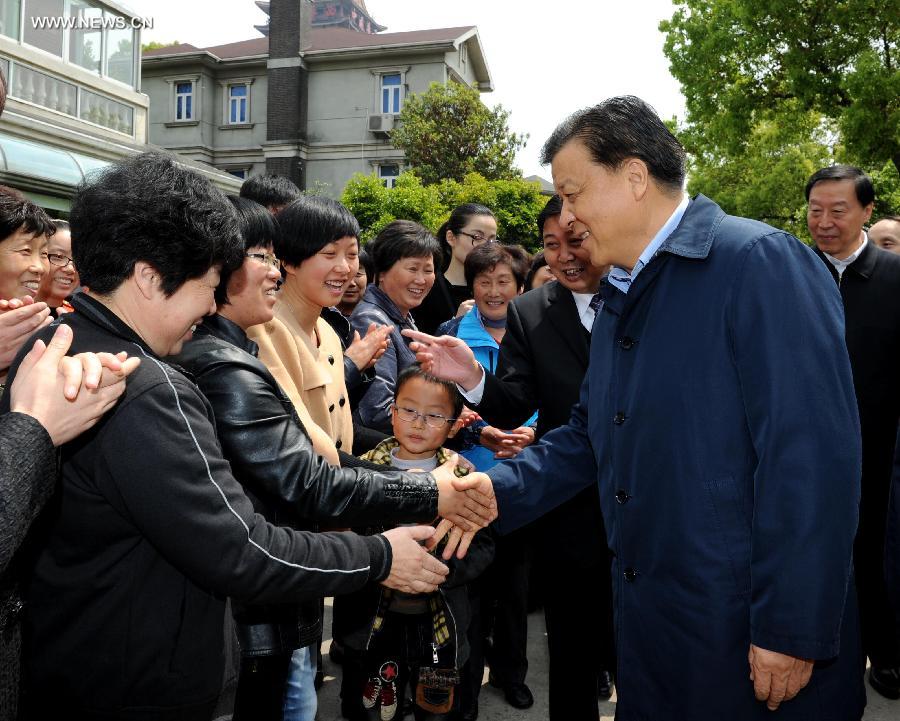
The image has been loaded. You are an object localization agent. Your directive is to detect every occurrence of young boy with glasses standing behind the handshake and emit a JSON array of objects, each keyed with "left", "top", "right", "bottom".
[{"left": 341, "top": 365, "right": 494, "bottom": 721}]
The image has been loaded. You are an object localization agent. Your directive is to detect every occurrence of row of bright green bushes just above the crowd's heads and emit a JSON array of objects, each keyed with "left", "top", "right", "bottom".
[{"left": 341, "top": 173, "right": 547, "bottom": 250}]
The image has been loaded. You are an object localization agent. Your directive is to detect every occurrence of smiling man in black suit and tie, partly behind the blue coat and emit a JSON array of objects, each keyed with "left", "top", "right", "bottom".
[{"left": 454, "top": 196, "right": 615, "bottom": 721}]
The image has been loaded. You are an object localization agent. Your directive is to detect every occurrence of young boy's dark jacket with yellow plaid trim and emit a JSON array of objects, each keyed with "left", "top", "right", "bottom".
[{"left": 342, "top": 438, "right": 494, "bottom": 669}]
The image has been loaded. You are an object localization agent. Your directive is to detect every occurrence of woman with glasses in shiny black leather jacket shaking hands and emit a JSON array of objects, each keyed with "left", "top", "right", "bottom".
[{"left": 173, "top": 198, "right": 491, "bottom": 719}]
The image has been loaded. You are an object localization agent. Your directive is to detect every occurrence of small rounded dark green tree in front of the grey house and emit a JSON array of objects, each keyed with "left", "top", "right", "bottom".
[{"left": 391, "top": 82, "right": 527, "bottom": 185}]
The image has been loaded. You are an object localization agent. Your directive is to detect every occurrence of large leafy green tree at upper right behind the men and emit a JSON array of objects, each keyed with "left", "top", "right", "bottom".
[{"left": 660, "top": 0, "right": 900, "bottom": 233}]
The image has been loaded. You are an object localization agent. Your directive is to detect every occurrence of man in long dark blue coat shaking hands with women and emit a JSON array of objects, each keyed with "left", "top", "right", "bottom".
[{"left": 416, "top": 97, "right": 865, "bottom": 721}]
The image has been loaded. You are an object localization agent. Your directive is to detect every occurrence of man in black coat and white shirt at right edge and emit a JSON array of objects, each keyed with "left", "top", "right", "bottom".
[{"left": 806, "top": 165, "right": 900, "bottom": 699}]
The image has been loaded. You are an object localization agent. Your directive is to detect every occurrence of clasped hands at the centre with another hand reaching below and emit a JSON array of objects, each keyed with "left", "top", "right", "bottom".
[{"left": 382, "top": 456, "right": 497, "bottom": 593}]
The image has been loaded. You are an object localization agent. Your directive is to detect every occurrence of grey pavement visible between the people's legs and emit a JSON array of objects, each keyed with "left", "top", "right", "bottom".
[{"left": 317, "top": 598, "right": 900, "bottom": 721}]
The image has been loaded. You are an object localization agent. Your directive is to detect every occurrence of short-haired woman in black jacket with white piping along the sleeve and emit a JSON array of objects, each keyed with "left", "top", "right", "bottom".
[{"left": 0, "top": 153, "right": 454, "bottom": 721}]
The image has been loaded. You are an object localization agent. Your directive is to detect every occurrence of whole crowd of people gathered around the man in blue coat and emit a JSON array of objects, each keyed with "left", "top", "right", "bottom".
[{"left": 0, "top": 64, "right": 900, "bottom": 721}]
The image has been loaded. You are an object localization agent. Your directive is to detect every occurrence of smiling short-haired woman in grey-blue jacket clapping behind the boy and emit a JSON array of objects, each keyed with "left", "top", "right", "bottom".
[{"left": 350, "top": 220, "right": 441, "bottom": 434}]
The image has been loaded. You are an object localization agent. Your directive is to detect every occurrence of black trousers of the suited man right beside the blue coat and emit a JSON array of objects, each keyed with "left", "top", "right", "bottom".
[{"left": 541, "top": 545, "right": 615, "bottom": 721}]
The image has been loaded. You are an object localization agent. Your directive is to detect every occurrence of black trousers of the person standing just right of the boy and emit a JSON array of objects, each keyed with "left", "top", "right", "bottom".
[{"left": 462, "top": 528, "right": 533, "bottom": 708}]
